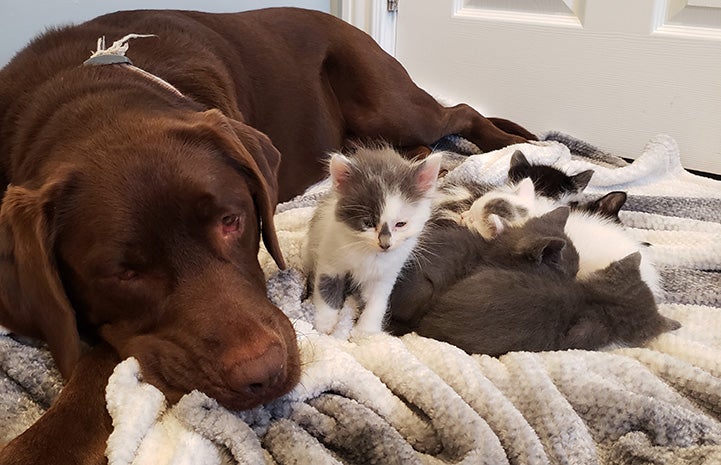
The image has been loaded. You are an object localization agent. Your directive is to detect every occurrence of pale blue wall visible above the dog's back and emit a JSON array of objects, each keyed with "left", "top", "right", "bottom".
[{"left": 0, "top": 0, "right": 337, "bottom": 67}]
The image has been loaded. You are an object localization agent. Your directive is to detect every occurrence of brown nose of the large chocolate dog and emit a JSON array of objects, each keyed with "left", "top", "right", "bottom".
[{"left": 224, "top": 344, "right": 286, "bottom": 397}]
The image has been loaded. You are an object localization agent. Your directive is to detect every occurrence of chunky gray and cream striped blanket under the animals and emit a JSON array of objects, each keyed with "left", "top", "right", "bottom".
[{"left": 0, "top": 133, "right": 721, "bottom": 465}]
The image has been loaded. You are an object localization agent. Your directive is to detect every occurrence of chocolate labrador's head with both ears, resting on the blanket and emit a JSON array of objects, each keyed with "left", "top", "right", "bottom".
[{"left": 0, "top": 110, "right": 299, "bottom": 409}]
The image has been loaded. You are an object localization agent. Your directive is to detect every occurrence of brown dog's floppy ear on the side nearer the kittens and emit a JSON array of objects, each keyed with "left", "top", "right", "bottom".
[{"left": 193, "top": 110, "right": 285, "bottom": 269}]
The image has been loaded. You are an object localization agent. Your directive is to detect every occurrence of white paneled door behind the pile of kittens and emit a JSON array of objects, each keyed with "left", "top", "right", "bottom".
[{"left": 376, "top": 0, "right": 721, "bottom": 173}]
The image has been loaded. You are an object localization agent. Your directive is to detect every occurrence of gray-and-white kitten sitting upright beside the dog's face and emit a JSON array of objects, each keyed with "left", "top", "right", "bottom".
[{"left": 304, "top": 147, "right": 442, "bottom": 337}]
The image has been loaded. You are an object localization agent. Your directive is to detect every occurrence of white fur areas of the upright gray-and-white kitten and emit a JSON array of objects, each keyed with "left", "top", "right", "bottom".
[{"left": 303, "top": 154, "right": 441, "bottom": 337}]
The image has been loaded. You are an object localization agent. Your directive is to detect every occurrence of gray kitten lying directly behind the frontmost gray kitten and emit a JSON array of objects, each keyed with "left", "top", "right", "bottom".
[{"left": 388, "top": 207, "right": 578, "bottom": 335}]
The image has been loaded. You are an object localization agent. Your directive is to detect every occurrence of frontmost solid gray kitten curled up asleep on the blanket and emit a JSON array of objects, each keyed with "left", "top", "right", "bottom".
[{"left": 412, "top": 252, "right": 680, "bottom": 356}]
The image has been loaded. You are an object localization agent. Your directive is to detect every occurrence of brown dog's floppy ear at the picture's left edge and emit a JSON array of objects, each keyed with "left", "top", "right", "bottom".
[{"left": 0, "top": 170, "right": 80, "bottom": 379}]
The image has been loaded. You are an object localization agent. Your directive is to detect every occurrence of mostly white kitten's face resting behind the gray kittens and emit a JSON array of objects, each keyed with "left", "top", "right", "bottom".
[{"left": 461, "top": 178, "right": 535, "bottom": 240}]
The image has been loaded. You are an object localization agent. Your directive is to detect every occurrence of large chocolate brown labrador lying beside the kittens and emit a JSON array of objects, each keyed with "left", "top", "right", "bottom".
[{"left": 0, "top": 8, "right": 533, "bottom": 463}]
